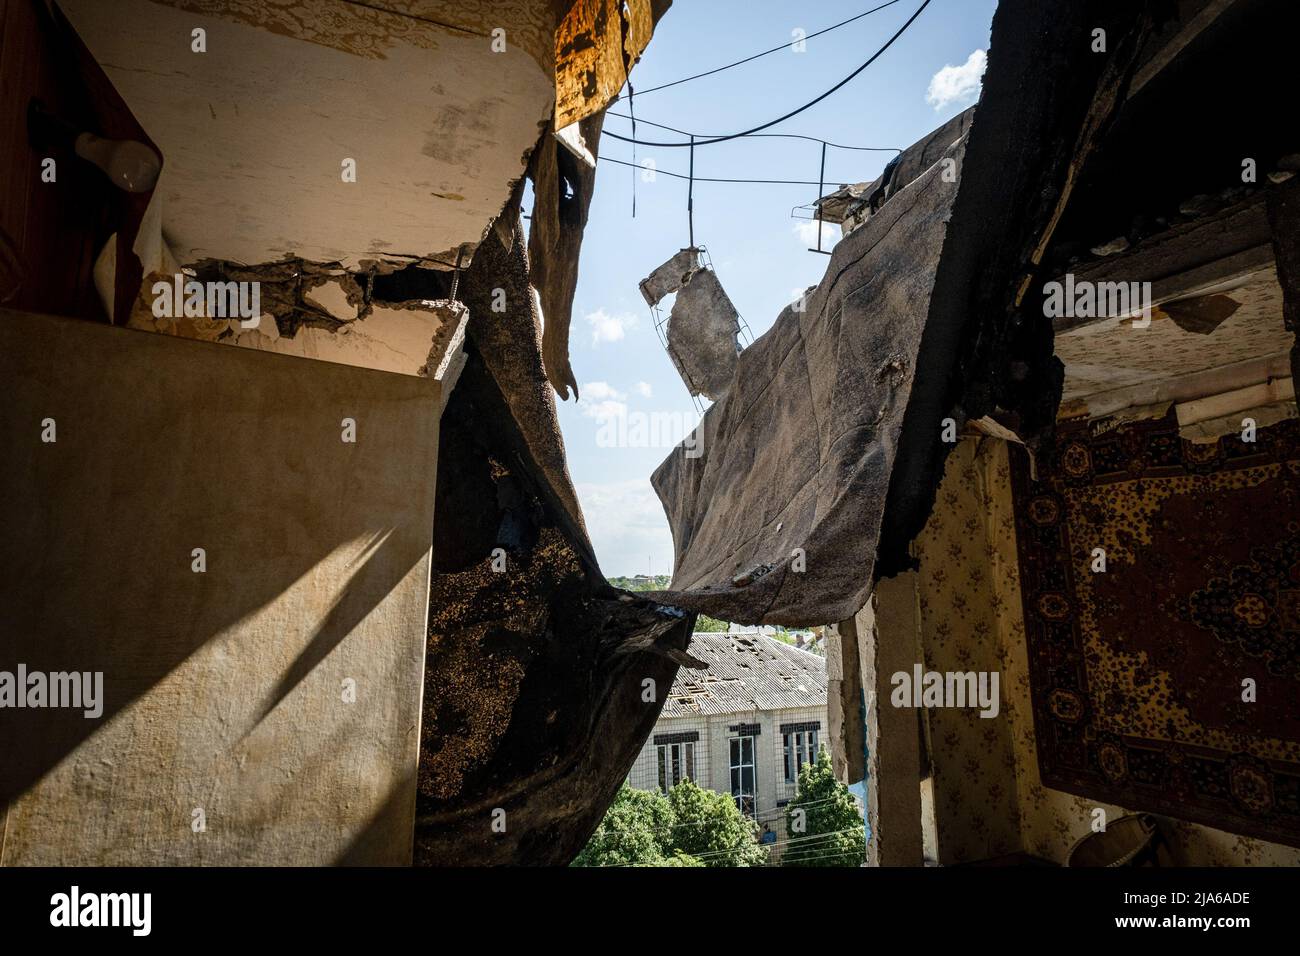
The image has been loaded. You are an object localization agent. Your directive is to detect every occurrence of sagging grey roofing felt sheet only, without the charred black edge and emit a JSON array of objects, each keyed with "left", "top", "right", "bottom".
[{"left": 653, "top": 134, "right": 965, "bottom": 624}]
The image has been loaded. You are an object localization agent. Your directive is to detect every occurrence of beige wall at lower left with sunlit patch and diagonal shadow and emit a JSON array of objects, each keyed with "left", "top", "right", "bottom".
[{"left": 0, "top": 310, "right": 439, "bottom": 866}]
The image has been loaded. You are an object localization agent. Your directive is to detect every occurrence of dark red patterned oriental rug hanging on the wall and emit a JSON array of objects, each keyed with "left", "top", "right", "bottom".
[{"left": 1013, "top": 418, "right": 1300, "bottom": 845}]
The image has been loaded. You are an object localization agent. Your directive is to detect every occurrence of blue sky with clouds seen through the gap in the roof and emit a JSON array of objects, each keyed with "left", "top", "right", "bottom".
[{"left": 548, "top": 0, "right": 996, "bottom": 576}]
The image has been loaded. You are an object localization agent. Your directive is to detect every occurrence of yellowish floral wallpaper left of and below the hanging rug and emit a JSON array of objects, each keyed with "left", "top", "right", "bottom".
[{"left": 914, "top": 437, "right": 1300, "bottom": 866}]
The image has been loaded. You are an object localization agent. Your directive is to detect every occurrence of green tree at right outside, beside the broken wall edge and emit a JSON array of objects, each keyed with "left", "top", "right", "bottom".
[{"left": 781, "top": 747, "right": 867, "bottom": 866}]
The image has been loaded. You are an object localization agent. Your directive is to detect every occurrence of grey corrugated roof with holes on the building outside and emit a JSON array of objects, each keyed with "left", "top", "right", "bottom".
[{"left": 662, "top": 632, "right": 826, "bottom": 717}]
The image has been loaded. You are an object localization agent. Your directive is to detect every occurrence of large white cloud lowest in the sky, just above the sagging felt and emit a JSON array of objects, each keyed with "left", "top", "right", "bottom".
[{"left": 577, "top": 479, "right": 672, "bottom": 575}]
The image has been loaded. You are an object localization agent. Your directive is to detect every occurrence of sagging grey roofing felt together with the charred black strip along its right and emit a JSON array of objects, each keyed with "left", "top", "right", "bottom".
[{"left": 651, "top": 0, "right": 1151, "bottom": 626}]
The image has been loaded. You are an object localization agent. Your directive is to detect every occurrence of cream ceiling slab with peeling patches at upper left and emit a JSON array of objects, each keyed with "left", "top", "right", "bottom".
[{"left": 60, "top": 0, "right": 555, "bottom": 268}]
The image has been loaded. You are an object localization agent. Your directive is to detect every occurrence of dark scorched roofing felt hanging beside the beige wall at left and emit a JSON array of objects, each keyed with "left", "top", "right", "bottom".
[{"left": 415, "top": 214, "right": 694, "bottom": 865}]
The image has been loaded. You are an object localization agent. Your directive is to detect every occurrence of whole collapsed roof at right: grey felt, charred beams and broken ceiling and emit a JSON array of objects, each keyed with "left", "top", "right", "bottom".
[{"left": 653, "top": 0, "right": 1300, "bottom": 626}]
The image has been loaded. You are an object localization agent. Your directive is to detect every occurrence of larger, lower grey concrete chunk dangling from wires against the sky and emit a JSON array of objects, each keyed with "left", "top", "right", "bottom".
[{"left": 667, "top": 268, "right": 740, "bottom": 402}]
